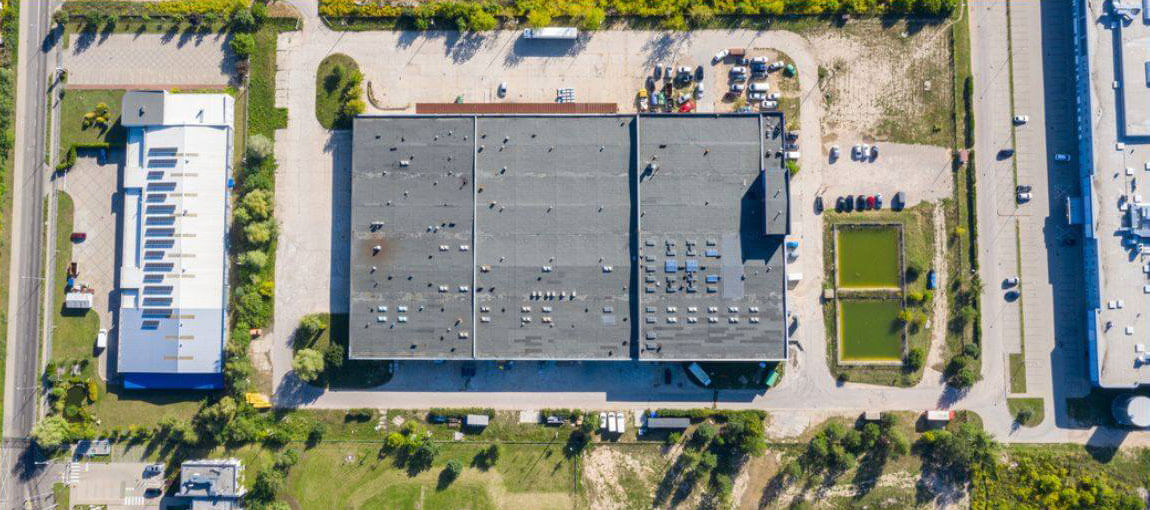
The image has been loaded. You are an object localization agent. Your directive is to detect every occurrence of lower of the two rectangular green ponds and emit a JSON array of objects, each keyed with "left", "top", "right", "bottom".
[{"left": 838, "top": 299, "right": 903, "bottom": 363}]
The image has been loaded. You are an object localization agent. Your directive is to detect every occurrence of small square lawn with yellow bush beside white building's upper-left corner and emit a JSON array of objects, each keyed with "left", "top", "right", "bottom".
[{"left": 60, "top": 90, "right": 125, "bottom": 159}]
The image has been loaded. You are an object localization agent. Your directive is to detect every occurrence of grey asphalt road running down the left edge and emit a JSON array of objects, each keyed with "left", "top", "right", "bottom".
[{"left": 0, "top": 1, "right": 56, "bottom": 510}]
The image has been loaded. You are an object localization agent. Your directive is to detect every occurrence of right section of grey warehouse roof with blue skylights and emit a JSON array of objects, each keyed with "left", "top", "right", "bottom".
[{"left": 639, "top": 116, "right": 788, "bottom": 360}]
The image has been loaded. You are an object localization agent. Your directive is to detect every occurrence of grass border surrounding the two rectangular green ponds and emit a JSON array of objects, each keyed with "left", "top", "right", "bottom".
[{"left": 822, "top": 203, "right": 944, "bottom": 387}]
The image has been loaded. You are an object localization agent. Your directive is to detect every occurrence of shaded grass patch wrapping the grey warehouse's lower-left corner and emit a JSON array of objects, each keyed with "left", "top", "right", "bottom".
[{"left": 292, "top": 313, "right": 392, "bottom": 388}]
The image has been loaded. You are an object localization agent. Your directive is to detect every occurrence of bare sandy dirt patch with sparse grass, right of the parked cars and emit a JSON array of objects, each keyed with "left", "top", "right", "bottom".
[{"left": 807, "top": 21, "right": 953, "bottom": 146}]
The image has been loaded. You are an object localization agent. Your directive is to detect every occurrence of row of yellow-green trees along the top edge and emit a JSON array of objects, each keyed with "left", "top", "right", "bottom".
[{"left": 320, "top": 0, "right": 957, "bottom": 31}]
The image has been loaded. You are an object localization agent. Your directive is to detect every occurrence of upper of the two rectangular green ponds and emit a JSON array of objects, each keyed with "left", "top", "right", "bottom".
[{"left": 835, "top": 224, "right": 899, "bottom": 289}]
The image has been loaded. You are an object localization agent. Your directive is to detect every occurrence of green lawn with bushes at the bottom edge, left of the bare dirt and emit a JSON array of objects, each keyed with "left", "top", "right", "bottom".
[{"left": 278, "top": 443, "right": 575, "bottom": 510}]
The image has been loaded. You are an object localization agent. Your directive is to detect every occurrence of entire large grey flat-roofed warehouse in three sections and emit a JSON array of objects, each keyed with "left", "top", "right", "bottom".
[{"left": 350, "top": 114, "right": 789, "bottom": 360}]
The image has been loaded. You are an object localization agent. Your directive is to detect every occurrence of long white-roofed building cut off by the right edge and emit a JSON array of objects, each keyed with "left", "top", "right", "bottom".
[{"left": 1067, "top": 0, "right": 1150, "bottom": 388}]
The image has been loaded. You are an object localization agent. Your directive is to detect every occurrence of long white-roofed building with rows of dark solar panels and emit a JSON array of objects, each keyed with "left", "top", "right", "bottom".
[{"left": 116, "top": 91, "right": 235, "bottom": 389}]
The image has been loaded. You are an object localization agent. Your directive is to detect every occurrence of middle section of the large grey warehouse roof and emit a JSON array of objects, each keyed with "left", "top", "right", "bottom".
[{"left": 475, "top": 116, "right": 635, "bottom": 359}]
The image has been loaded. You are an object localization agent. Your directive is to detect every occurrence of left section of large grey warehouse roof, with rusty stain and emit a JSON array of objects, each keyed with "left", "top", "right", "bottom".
[{"left": 350, "top": 117, "right": 475, "bottom": 359}]
